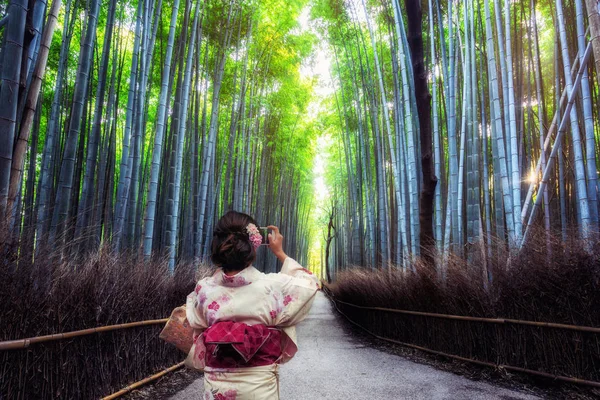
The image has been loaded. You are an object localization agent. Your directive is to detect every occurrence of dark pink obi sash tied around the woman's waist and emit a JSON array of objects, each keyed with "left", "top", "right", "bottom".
[{"left": 202, "top": 321, "right": 281, "bottom": 368}]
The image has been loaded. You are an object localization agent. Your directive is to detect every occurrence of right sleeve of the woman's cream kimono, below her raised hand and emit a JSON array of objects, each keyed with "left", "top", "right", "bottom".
[{"left": 277, "top": 257, "right": 319, "bottom": 326}]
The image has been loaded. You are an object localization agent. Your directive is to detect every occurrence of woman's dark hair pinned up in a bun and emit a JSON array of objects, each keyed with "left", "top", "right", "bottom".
[{"left": 211, "top": 211, "right": 258, "bottom": 272}]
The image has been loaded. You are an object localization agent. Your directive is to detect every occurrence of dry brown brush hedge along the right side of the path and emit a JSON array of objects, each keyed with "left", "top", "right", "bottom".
[{"left": 329, "top": 233, "right": 600, "bottom": 382}]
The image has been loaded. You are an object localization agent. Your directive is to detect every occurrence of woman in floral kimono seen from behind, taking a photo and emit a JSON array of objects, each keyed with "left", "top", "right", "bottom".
[{"left": 186, "top": 211, "right": 319, "bottom": 400}]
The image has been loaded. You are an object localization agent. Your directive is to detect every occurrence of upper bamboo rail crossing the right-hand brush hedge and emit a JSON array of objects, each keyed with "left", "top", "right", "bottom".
[{"left": 332, "top": 297, "right": 600, "bottom": 333}]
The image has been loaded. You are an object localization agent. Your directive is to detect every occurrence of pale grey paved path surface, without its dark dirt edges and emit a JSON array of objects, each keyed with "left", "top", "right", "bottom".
[{"left": 171, "top": 292, "right": 538, "bottom": 400}]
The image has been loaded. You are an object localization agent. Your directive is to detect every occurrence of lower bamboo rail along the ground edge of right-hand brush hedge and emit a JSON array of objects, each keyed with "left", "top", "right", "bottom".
[{"left": 333, "top": 300, "right": 600, "bottom": 388}]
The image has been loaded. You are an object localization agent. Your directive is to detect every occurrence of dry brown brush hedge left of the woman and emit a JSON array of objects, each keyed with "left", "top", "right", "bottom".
[{"left": 0, "top": 236, "right": 207, "bottom": 399}]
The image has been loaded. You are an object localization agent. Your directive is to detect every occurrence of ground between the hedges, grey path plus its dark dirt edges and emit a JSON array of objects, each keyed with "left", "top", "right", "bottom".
[{"left": 119, "top": 293, "right": 595, "bottom": 400}]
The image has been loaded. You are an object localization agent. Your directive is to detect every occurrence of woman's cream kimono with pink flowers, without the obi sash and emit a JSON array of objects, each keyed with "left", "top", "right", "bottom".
[{"left": 186, "top": 257, "right": 319, "bottom": 400}]
